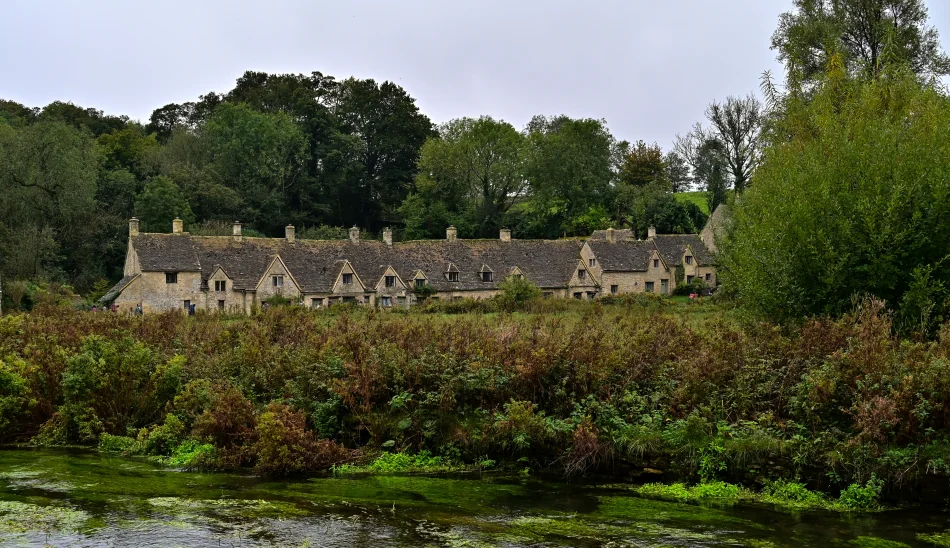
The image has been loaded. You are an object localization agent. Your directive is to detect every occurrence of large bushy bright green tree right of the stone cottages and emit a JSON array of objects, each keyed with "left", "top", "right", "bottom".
[{"left": 721, "top": 64, "right": 950, "bottom": 326}]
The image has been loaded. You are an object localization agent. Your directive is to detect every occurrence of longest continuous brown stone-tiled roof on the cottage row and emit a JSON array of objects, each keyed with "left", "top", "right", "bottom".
[{"left": 132, "top": 234, "right": 581, "bottom": 293}]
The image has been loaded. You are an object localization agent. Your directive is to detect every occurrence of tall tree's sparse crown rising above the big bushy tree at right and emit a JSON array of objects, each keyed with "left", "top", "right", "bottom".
[{"left": 772, "top": 0, "right": 950, "bottom": 89}]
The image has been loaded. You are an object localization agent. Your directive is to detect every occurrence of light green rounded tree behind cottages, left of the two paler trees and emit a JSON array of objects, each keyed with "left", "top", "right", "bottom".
[{"left": 400, "top": 116, "right": 527, "bottom": 238}]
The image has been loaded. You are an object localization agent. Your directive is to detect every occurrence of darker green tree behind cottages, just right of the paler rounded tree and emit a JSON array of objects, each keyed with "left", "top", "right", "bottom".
[{"left": 517, "top": 116, "right": 615, "bottom": 238}]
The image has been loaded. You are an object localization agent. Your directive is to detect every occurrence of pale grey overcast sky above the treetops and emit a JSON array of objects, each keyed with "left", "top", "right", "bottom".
[{"left": 0, "top": 0, "right": 950, "bottom": 149}]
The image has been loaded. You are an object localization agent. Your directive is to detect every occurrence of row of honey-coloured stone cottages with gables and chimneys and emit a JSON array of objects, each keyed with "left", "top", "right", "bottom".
[{"left": 102, "top": 211, "right": 720, "bottom": 313}]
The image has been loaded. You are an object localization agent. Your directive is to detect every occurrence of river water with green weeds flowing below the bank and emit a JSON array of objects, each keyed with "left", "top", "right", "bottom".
[{"left": 0, "top": 449, "right": 950, "bottom": 548}]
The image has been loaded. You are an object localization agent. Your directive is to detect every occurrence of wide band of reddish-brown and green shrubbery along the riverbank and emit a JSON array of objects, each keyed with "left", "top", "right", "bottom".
[{"left": 0, "top": 301, "right": 950, "bottom": 497}]
